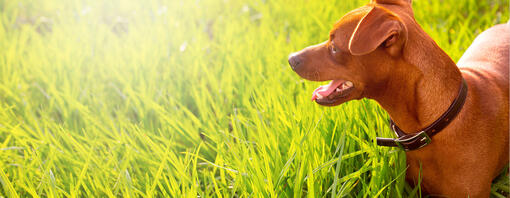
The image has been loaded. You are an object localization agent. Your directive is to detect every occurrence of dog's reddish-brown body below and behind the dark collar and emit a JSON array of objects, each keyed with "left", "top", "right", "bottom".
[{"left": 407, "top": 24, "right": 510, "bottom": 197}]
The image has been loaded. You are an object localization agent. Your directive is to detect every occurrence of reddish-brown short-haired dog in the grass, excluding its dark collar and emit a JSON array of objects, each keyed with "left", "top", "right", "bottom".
[{"left": 289, "top": 0, "right": 510, "bottom": 197}]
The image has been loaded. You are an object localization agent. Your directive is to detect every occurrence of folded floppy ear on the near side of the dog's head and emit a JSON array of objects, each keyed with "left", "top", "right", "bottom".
[{"left": 349, "top": 6, "right": 407, "bottom": 56}]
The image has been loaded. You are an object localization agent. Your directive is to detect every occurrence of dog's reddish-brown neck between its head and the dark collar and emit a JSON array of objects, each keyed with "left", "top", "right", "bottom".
[{"left": 373, "top": 29, "right": 462, "bottom": 133}]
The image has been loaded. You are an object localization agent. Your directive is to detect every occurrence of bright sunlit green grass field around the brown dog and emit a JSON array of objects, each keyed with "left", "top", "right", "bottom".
[{"left": 0, "top": 0, "right": 509, "bottom": 197}]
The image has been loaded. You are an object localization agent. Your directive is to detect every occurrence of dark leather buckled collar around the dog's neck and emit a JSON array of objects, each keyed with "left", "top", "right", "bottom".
[{"left": 377, "top": 78, "right": 467, "bottom": 151}]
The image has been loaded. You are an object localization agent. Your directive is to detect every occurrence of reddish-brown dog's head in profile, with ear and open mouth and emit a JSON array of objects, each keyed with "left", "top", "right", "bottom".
[{"left": 289, "top": 0, "right": 414, "bottom": 106}]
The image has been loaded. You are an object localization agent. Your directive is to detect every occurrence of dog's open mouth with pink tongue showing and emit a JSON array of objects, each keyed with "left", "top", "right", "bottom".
[{"left": 312, "top": 80, "right": 354, "bottom": 106}]
